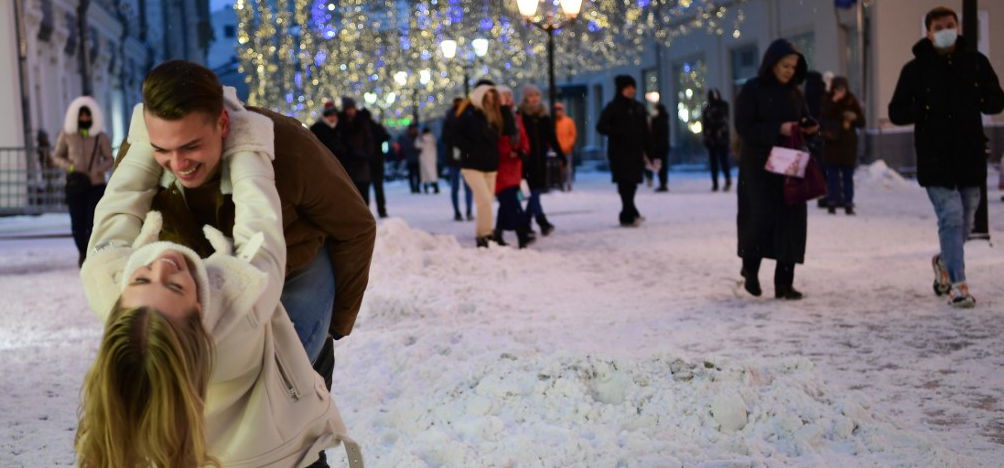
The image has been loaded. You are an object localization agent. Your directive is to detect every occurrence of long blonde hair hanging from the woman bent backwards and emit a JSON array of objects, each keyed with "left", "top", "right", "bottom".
[{"left": 75, "top": 302, "right": 221, "bottom": 468}]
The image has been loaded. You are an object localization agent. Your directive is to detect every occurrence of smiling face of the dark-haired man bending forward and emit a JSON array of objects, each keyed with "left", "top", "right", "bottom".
[{"left": 143, "top": 110, "right": 230, "bottom": 189}]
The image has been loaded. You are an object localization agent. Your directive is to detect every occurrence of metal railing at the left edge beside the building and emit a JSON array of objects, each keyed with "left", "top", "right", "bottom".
[{"left": 0, "top": 147, "right": 66, "bottom": 216}]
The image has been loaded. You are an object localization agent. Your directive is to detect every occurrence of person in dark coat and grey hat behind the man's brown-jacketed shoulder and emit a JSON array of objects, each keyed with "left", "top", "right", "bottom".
[{"left": 334, "top": 96, "right": 374, "bottom": 202}]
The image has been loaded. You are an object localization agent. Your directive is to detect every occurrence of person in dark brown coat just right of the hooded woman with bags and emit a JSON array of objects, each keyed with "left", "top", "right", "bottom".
[{"left": 820, "top": 76, "right": 864, "bottom": 215}]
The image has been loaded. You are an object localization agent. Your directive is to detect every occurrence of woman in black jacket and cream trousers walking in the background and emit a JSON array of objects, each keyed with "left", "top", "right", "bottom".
[{"left": 452, "top": 79, "right": 504, "bottom": 248}]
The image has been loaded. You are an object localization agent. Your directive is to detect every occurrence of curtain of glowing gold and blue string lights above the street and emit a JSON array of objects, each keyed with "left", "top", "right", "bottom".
[{"left": 234, "top": 0, "right": 745, "bottom": 125}]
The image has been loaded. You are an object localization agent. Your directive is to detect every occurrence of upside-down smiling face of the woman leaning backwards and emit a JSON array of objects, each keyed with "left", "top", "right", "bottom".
[{"left": 120, "top": 249, "right": 201, "bottom": 319}]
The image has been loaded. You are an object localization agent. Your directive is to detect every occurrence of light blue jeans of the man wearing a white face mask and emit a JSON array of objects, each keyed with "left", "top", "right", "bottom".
[{"left": 928, "top": 187, "right": 980, "bottom": 284}]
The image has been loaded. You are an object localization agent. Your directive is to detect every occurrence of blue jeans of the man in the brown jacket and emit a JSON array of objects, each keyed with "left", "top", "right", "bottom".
[{"left": 279, "top": 247, "right": 334, "bottom": 363}]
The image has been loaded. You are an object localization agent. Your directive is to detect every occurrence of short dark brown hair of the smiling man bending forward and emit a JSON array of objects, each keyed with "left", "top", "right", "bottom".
[{"left": 143, "top": 60, "right": 223, "bottom": 121}]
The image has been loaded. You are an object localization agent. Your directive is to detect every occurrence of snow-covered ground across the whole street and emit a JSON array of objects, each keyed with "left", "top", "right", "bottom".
[{"left": 0, "top": 164, "right": 1004, "bottom": 467}]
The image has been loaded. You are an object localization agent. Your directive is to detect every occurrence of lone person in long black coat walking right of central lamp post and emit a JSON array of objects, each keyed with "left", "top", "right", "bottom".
[{"left": 596, "top": 74, "right": 652, "bottom": 227}]
